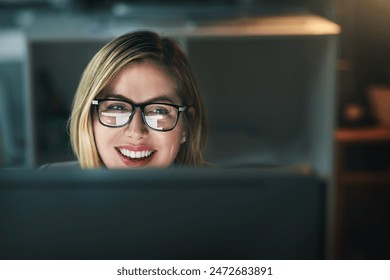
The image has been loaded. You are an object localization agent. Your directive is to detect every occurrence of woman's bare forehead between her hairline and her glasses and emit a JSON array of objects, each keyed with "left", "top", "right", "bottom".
[{"left": 99, "top": 61, "right": 180, "bottom": 103}]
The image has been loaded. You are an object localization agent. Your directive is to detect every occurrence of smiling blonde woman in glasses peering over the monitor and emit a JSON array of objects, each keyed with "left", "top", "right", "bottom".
[{"left": 69, "top": 31, "right": 207, "bottom": 168}]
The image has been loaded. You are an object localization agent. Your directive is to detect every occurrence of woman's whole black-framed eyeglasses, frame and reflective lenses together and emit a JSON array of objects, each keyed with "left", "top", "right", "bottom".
[{"left": 92, "top": 99, "right": 187, "bottom": 131}]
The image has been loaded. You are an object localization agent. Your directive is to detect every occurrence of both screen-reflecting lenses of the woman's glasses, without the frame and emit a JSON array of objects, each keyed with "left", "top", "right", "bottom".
[{"left": 99, "top": 100, "right": 178, "bottom": 131}]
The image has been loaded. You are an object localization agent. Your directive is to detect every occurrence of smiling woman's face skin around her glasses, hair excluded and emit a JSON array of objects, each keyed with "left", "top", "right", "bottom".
[{"left": 93, "top": 62, "right": 185, "bottom": 168}]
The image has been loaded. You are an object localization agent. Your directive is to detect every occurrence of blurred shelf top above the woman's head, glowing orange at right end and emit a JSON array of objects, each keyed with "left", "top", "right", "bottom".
[{"left": 13, "top": 13, "right": 341, "bottom": 40}]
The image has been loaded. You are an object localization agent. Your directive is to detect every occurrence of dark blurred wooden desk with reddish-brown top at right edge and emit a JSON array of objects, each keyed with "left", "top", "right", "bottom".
[{"left": 334, "top": 127, "right": 390, "bottom": 259}]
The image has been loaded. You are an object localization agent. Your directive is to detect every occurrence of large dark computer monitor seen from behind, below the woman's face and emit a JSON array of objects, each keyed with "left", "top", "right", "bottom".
[{"left": 0, "top": 168, "right": 325, "bottom": 260}]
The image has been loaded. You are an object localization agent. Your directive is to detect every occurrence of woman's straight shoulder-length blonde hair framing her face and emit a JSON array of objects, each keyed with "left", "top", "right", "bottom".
[{"left": 69, "top": 31, "right": 207, "bottom": 168}]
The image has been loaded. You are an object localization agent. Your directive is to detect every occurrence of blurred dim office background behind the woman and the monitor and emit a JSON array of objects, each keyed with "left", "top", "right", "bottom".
[{"left": 0, "top": 0, "right": 390, "bottom": 258}]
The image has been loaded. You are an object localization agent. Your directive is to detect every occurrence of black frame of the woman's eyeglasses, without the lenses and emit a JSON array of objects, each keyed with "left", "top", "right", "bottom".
[{"left": 91, "top": 98, "right": 188, "bottom": 132}]
